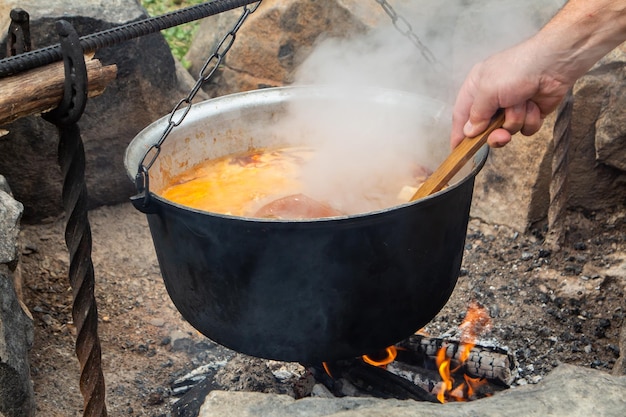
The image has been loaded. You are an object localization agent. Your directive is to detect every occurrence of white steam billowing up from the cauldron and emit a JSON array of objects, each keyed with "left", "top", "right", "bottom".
[{"left": 272, "top": 0, "right": 564, "bottom": 211}]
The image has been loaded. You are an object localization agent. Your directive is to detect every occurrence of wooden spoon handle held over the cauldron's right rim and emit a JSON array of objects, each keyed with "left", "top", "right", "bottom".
[{"left": 410, "top": 110, "right": 504, "bottom": 201}]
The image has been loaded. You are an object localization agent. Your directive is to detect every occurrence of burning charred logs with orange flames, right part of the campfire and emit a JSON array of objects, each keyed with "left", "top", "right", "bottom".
[{"left": 313, "top": 303, "right": 516, "bottom": 403}]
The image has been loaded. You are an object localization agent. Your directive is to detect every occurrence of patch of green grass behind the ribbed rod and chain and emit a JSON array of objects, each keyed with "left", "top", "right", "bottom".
[{"left": 141, "top": 0, "right": 206, "bottom": 68}]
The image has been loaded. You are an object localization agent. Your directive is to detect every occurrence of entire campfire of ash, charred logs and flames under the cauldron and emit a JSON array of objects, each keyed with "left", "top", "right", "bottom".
[{"left": 172, "top": 304, "right": 518, "bottom": 416}]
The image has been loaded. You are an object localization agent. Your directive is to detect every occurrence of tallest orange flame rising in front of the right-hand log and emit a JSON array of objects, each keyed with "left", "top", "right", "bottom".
[{"left": 436, "top": 303, "right": 490, "bottom": 403}]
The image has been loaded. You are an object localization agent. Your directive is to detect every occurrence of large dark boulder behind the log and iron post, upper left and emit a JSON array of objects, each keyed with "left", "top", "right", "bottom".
[{"left": 0, "top": 0, "right": 202, "bottom": 221}]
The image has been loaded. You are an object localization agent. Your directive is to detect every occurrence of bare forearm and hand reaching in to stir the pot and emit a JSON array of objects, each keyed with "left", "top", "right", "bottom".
[{"left": 450, "top": 0, "right": 626, "bottom": 147}]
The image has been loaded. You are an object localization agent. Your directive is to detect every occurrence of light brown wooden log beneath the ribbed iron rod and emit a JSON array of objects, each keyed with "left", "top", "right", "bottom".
[{"left": 0, "top": 55, "right": 117, "bottom": 126}]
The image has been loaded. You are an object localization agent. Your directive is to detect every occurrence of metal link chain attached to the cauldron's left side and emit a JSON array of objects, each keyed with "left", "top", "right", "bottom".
[{"left": 135, "top": 0, "right": 262, "bottom": 198}]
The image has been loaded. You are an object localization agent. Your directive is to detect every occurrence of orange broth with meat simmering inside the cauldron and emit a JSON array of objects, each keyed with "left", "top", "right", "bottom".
[{"left": 159, "top": 147, "right": 429, "bottom": 219}]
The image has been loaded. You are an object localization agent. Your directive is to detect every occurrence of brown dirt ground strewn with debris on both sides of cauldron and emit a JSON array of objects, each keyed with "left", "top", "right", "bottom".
[{"left": 21, "top": 204, "right": 626, "bottom": 417}]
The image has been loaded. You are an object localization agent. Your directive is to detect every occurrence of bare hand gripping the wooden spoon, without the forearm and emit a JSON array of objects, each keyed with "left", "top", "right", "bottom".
[{"left": 450, "top": 38, "right": 573, "bottom": 148}]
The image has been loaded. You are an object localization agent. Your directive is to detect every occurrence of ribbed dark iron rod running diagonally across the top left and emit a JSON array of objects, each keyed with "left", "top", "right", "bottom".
[{"left": 0, "top": 0, "right": 258, "bottom": 78}]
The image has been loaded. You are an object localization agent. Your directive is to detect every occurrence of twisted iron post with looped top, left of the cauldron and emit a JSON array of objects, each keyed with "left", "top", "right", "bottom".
[{"left": 43, "top": 20, "right": 107, "bottom": 417}]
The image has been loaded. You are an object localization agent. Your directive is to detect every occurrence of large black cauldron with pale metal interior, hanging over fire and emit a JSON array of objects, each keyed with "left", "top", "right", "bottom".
[{"left": 125, "top": 86, "right": 488, "bottom": 363}]
